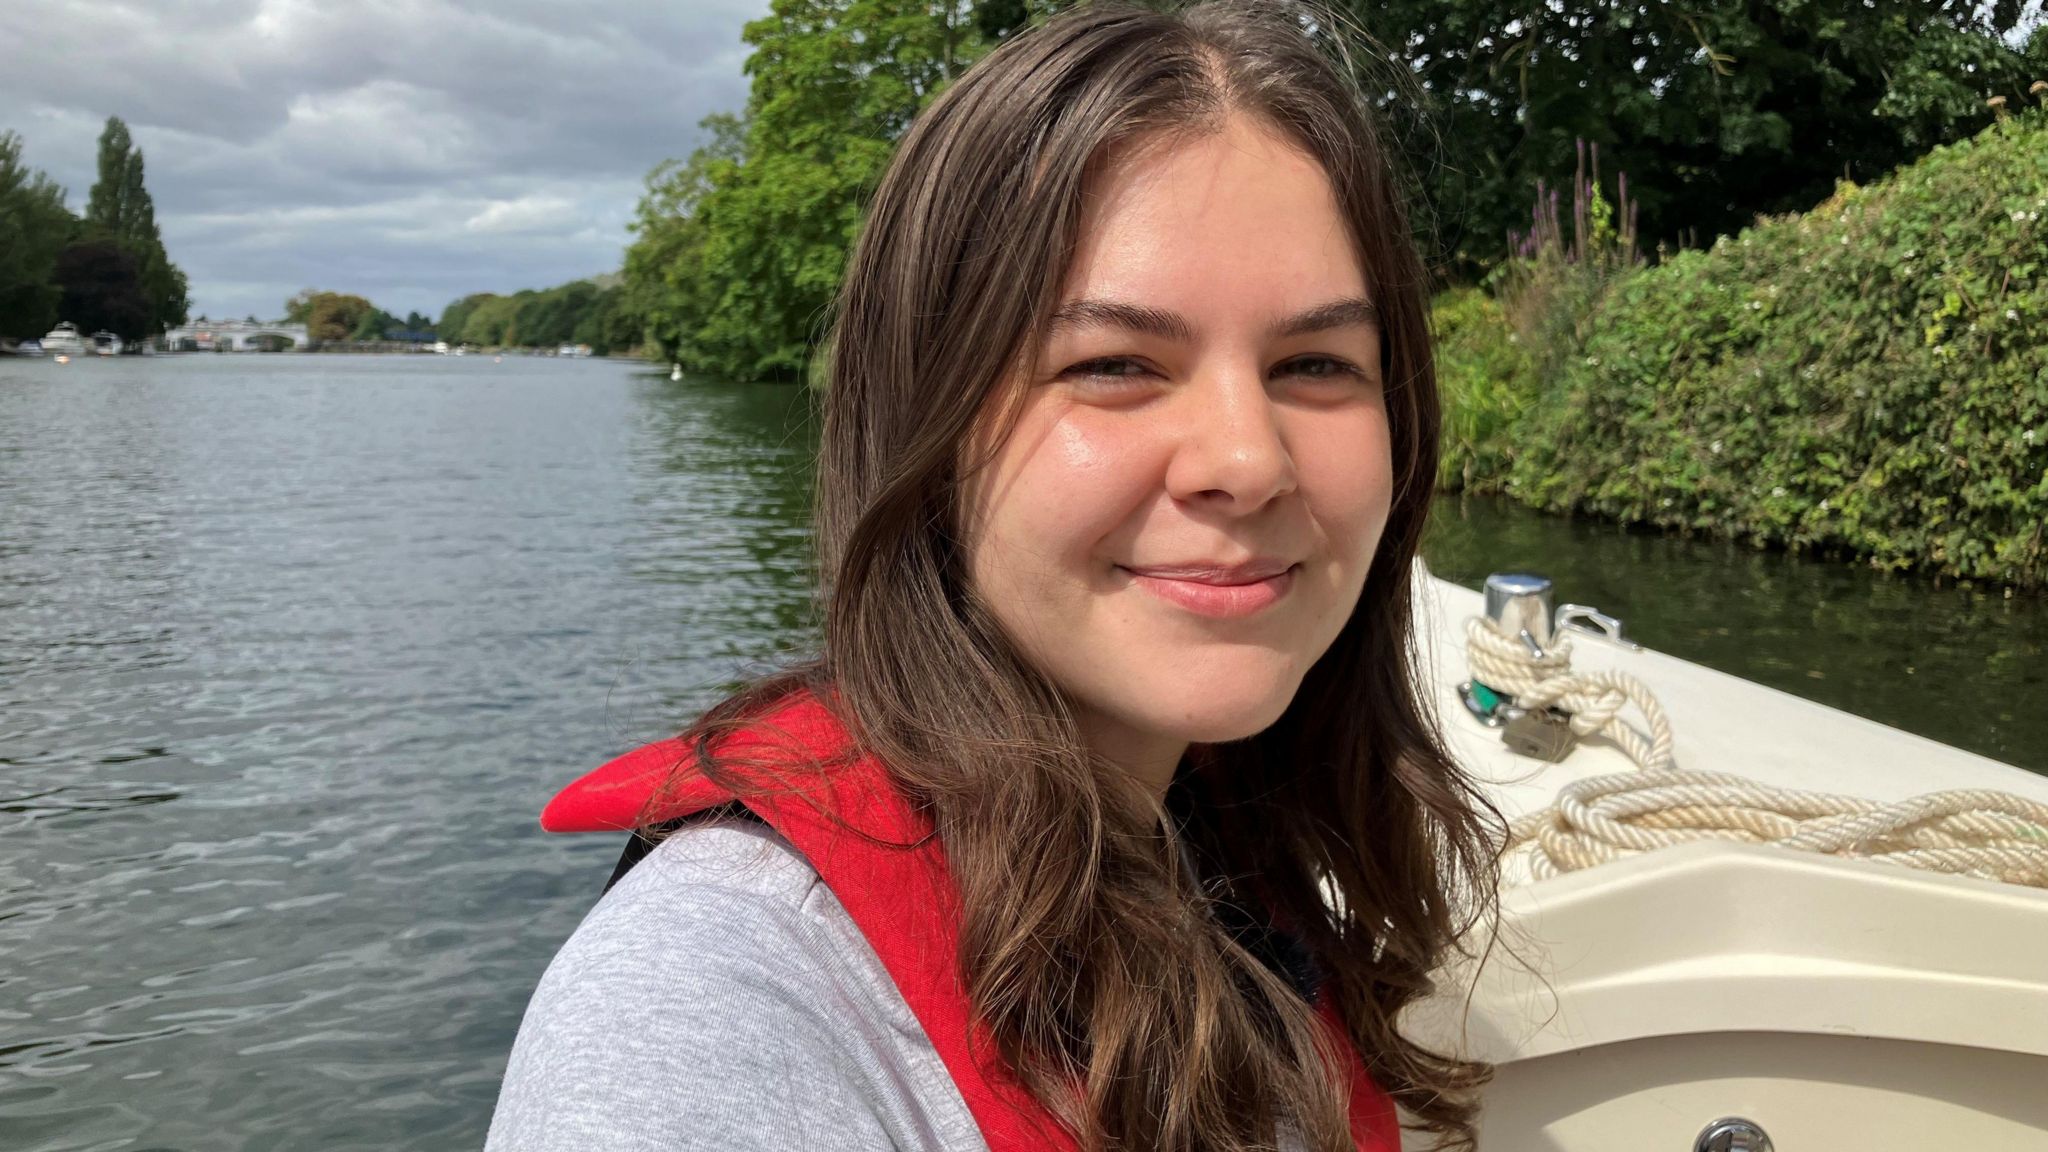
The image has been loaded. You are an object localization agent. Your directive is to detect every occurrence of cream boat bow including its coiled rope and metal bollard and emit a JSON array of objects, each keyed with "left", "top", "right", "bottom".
[{"left": 1403, "top": 566, "right": 2048, "bottom": 1152}]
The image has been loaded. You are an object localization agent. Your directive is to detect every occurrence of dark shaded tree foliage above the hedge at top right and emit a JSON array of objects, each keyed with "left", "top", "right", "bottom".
[{"left": 1350, "top": 0, "right": 2048, "bottom": 273}]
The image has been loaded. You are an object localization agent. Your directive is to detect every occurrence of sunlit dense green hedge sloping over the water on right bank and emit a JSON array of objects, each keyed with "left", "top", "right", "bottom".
[{"left": 1452, "top": 111, "right": 2048, "bottom": 586}]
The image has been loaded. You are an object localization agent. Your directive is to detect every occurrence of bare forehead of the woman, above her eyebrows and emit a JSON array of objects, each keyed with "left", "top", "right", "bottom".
[{"left": 1063, "top": 117, "right": 1366, "bottom": 318}]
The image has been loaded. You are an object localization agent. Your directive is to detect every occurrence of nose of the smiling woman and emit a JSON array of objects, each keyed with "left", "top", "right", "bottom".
[{"left": 1165, "top": 365, "right": 1296, "bottom": 512}]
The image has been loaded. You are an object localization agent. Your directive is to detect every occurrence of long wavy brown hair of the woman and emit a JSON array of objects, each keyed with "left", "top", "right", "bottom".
[{"left": 671, "top": 2, "right": 1495, "bottom": 1152}]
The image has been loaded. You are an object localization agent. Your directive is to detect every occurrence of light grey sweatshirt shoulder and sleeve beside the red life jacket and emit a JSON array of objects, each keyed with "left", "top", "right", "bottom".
[{"left": 485, "top": 820, "right": 987, "bottom": 1152}]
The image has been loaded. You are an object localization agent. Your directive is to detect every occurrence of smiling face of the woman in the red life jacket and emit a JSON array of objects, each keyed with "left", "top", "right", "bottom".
[{"left": 969, "top": 117, "right": 1393, "bottom": 789}]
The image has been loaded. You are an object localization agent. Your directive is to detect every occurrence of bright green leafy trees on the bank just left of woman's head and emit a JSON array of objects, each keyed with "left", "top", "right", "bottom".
[{"left": 625, "top": 0, "right": 1007, "bottom": 379}]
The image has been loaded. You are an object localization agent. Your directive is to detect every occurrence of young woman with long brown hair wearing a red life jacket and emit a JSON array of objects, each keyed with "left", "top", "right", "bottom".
[{"left": 489, "top": 4, "right": 1493, "bottom": 1152}]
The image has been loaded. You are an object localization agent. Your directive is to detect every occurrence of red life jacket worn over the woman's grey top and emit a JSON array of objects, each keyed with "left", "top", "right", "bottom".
[{"left": 541, "top": 695, "right": 1401, "bottom": 1152}]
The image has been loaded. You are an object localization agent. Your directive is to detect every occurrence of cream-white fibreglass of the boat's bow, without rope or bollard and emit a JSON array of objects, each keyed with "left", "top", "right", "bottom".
[{"left": 1403, "top": 574, "right": 2048, "bottom": 1152}]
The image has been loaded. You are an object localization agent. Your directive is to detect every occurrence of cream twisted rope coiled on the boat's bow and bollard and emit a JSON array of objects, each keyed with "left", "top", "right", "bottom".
[{"left": 1466, "top": 619, "right": 2048, "bottom": 888}]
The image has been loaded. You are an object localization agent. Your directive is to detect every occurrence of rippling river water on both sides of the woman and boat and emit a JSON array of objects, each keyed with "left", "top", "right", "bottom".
[{"left": 0, "top": 357, "right": 2048, "bottom": 1152}]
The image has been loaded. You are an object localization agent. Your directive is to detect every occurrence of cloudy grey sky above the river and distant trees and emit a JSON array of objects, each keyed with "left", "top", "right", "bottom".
[{"left": 0, "top": 0, "right": 768, "bottom": 318}]
